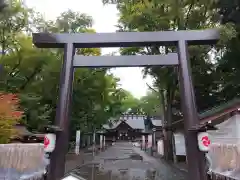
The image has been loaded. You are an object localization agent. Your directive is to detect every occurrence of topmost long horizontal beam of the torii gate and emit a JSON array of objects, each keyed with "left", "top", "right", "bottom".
[{"left": 33, "top": 29, "right": 220, "bottom": 48}]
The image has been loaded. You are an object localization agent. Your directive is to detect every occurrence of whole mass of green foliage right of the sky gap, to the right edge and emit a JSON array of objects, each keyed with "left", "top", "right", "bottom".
[{"left": 103, "top": 0, "right": 239, "bottom": 160}]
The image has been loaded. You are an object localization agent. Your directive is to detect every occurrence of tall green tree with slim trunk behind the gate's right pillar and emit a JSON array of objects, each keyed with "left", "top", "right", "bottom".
[{"left": 104, "top": 0, "right": 219, "bottom": 159}]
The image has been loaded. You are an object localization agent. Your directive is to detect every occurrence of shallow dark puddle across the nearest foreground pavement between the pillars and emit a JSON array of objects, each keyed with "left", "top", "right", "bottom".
[{"left": 72, "top": 163, "right": 159, "bottom": 180}]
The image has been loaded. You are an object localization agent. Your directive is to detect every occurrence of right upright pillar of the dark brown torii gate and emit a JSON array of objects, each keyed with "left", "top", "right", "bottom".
[{"left": 178, "top": 41, "right": 207, "bottom": 180}]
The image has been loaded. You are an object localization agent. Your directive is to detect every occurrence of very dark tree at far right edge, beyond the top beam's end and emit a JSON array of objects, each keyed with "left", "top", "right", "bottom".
[{"left": 216, "top": 0, "right": 240, "bottom": 102}]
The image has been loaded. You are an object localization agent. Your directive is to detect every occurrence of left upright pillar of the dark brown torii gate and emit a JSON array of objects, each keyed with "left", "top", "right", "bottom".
[{"left": 47, "top": 44, "right": 75, "bottom": 180}]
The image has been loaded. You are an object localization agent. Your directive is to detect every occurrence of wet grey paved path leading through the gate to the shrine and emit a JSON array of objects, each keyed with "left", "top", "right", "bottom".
[{"left": 69, "top": 142, "right": 186, "bottom": 180}]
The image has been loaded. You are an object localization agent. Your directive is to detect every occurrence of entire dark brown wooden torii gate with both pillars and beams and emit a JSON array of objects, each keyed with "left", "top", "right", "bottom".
[{"left": 33, "top": 29, "right": 219, "bottom": 180}]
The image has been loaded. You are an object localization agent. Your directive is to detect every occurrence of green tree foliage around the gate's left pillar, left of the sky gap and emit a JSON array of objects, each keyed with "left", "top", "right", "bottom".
[{"left": 0, "top": 0, "right": 135, "bottom": 143}]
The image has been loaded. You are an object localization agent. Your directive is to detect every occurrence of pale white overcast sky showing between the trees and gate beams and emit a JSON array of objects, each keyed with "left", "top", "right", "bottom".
[{"left": 24, "top": 0, "right": 152, "bottom": 98}]
